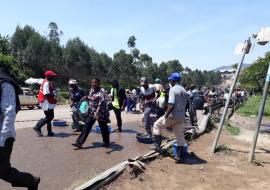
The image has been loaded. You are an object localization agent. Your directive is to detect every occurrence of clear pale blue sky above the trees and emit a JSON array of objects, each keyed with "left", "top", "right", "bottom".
[{"left": 0, "top": 0, "right": 270, "bottom": 70}]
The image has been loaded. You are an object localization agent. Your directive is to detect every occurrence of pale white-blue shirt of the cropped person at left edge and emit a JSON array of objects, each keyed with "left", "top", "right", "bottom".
[{"left": 0, "top": 82, "right": 16, "bottom": 147}]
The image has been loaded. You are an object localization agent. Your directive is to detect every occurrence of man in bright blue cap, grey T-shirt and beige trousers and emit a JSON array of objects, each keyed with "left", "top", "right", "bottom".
[{"left": 153, "top": 72, "right": 188, "bottom": 163}]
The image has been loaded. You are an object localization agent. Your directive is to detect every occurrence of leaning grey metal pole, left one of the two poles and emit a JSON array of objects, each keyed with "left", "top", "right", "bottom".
[{"left": 212, "top": 38, "right": 250, "bottom": 153}]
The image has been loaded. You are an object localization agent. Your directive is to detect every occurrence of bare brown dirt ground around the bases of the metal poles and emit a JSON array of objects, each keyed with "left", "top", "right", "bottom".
[{"left": 104, "top": 127, "right": 270, "bottom": 190}]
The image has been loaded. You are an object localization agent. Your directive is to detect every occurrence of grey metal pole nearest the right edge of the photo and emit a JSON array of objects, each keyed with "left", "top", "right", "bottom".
[{"left": 248, "top": 63, "right": 270, "bottom": 163}]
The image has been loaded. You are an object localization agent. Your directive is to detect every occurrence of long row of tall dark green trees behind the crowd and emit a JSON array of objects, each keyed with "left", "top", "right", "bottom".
[{"left": 0, "top": 22, "right": 223, "bottom": 90}]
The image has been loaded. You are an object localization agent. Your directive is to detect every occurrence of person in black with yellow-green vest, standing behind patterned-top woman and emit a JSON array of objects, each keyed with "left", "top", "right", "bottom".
[{"left": 109, "top": 80, "right": 127, "bottom": 132}]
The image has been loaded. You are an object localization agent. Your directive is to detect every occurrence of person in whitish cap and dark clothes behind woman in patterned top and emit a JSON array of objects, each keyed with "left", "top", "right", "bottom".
[{"left": 68, "top": 79, "right": 85, "bottom": 132}]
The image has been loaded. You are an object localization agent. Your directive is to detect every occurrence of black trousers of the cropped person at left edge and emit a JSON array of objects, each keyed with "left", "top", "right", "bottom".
[{"left": 0, "top": 138, "right": 35, "bottom": 190}]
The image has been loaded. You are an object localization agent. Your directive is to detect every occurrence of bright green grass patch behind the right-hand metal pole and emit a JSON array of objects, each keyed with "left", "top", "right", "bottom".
[{"left": 236, "top": 96, "right": 270, "bottom": 117}]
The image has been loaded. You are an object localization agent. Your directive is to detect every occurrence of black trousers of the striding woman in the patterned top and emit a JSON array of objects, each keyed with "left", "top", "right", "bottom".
[{"left": 76, "top": 117, "right": 110, "bottom": 145}]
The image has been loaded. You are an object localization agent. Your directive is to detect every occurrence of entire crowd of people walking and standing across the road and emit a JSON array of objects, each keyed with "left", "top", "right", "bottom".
[{"left": 0, "top": 70, "right": 249, "bottom": 190}]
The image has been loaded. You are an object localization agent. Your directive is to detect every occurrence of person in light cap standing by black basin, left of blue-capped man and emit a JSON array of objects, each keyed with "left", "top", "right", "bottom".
[{"left": 140, "top": 77, "right": 159, "bottom": 137}]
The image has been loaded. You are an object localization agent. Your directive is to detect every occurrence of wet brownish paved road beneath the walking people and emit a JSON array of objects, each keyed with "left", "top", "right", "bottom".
[{"left": 0, "top": 106, "right": 149, "bottom": 190}]
